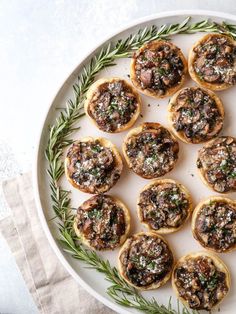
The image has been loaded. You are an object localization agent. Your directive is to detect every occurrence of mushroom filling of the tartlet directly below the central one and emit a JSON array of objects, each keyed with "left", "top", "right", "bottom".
[{"left": 138, "top": 183, "right": 189, "bottom": 230}]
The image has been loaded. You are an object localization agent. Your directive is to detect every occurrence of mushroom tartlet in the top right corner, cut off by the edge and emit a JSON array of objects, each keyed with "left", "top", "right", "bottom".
[{"left": 188, "top": 34, "right": 236, "bottom": 90}]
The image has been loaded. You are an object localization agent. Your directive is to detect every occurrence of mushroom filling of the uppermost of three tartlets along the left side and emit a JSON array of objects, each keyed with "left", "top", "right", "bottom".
[{"left": 88, "top": 81, "right": 138, "bottom": 132}]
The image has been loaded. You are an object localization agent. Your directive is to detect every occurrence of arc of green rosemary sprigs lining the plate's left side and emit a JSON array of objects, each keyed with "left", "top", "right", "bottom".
[{"left": 45, "top": 17, "right": 236, "bottom": 314}]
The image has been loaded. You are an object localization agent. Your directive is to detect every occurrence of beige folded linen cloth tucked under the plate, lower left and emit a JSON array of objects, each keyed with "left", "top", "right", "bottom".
[{"left": 0, "top": 174, "right": 115, "bottom": 314}]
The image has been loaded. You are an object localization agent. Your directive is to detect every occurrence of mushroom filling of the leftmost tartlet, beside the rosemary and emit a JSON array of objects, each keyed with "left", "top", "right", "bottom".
[{"left": 67, "top": 140, "right": 120, "bottom": 192}]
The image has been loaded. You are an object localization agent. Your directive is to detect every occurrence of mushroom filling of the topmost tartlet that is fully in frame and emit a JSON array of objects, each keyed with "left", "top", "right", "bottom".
[{"left": 134, "top": 43, "right": 184, "bottom": 95}]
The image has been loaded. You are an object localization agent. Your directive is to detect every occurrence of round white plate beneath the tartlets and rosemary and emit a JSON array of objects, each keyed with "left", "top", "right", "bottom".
[{"left": 34, "top": 11, "right": 236, "bottom": 314}]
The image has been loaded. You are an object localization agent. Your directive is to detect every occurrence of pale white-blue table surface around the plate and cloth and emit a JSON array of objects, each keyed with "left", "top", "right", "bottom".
[{"left": 0, "top": 0, "right": 236, "bottom": 314}]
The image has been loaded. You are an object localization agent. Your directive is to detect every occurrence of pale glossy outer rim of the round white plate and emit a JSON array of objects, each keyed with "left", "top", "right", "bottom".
[{"left": 32, "top": 9, "right": 236, "bottom": 314}]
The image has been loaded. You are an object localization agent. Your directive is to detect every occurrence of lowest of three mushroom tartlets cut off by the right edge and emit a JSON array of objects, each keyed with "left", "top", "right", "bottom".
[{"left": 192, "top": 196, "right": 236, "bottom": 253}]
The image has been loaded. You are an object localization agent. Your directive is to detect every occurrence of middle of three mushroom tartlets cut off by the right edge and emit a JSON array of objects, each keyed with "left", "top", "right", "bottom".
[{"left": 197, "top": 136, "right": 236, "bottom": 193}]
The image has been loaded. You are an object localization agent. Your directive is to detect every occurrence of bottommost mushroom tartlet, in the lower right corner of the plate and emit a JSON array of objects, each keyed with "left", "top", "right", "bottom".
[{"left": 172, "top": 252, "right": 230, "bottom": 311}]
